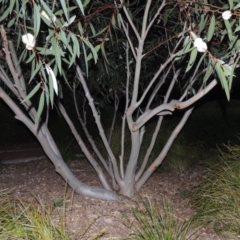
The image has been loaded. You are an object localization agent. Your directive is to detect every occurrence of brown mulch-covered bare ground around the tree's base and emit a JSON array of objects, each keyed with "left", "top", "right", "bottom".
[{"left": 0, "top": 144, "right": 220, "bottom": 240}]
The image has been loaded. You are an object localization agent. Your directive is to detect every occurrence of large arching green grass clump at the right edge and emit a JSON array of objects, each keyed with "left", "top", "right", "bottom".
[{"left": 191, "top": 145, "right": 240, "bottom": 239}]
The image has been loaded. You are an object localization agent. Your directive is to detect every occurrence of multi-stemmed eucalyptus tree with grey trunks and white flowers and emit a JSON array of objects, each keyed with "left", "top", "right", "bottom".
[{"left": 0, "top": 0, "right": 240, "bottom": 200}]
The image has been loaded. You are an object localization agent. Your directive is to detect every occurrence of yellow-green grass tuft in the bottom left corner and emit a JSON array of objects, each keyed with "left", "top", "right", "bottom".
[{"left": 0, "top": 190, "right": 69, "bottom": 240}]
